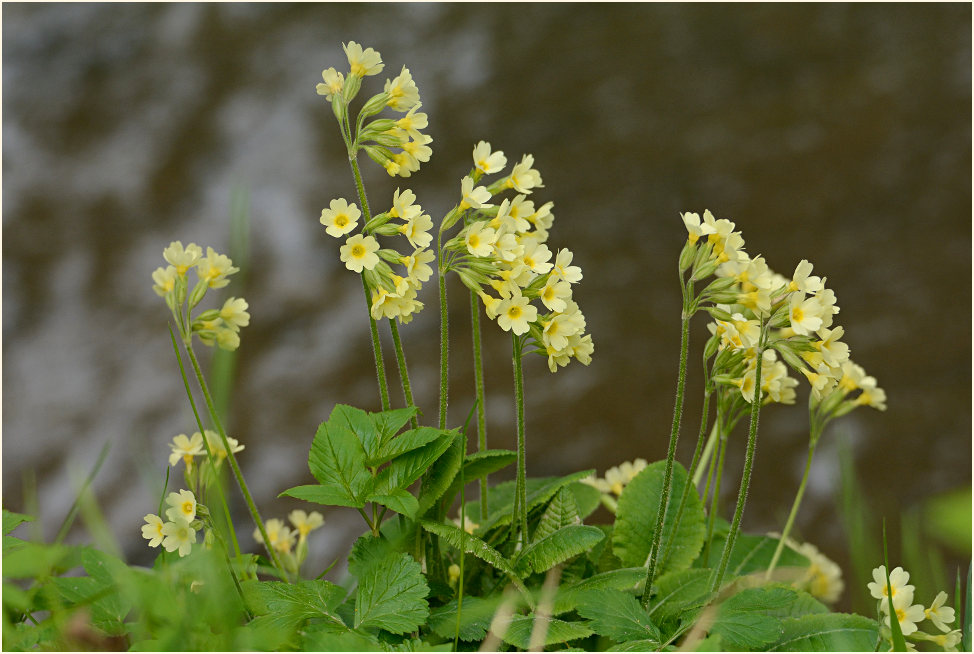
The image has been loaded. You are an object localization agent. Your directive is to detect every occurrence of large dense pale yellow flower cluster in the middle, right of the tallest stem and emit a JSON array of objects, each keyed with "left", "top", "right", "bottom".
[{"left": 441, "top": 141, "right": 595, "bottom": 372}]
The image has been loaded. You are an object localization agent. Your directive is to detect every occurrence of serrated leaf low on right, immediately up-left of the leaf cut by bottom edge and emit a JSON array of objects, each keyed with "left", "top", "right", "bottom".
[{"left": 710, "top": 588, "right": 789, "bottom": 649}]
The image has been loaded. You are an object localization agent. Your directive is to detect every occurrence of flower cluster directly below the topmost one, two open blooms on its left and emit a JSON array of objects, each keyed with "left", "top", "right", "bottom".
[{"left": 321, "top": 189, "right": 436, "bottom": 323}]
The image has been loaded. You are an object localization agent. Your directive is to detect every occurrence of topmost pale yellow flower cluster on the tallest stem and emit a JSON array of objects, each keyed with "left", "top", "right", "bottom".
[{"left": 316, "top": 41, "right": 433, "bottom": 177}]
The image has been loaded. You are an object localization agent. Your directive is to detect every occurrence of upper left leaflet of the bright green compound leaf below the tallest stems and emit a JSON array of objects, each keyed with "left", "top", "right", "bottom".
[{"left": 308, "top": 416, "right": 375, "bottom": 508}]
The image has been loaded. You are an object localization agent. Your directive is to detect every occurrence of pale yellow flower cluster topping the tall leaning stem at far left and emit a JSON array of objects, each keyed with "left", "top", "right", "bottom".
[{"left": 152, "top": 241, "right": 250, "bottom": 351}]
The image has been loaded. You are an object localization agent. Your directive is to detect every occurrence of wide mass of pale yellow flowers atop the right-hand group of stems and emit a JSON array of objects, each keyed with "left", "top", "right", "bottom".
[{"left": 680, "top": 211, "right": 886, "bottom": 416}]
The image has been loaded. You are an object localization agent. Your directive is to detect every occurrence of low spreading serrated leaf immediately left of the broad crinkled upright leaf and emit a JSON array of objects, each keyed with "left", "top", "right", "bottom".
[{"left": 241, "top": 579, "right": 348, "bottom": 631}]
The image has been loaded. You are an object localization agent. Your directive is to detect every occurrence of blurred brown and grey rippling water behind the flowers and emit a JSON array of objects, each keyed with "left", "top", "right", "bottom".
[{"left": 2, "top": 3, "right": 971, "bottom": 606}]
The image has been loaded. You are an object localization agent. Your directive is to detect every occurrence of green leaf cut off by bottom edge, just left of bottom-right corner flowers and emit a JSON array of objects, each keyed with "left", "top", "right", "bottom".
[{"left": 768, "top": 613, "right": 879, "bottom": 652}]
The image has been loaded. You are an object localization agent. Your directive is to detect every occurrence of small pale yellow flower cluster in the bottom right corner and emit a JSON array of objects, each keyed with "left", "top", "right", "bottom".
[{"left": 866, "top": 565, "right": 961, "bottom": 652}]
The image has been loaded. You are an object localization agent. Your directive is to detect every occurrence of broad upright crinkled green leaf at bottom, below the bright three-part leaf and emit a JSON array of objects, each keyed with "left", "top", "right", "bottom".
[{"left": 355, "top": 551, "right": 429, "bottom": 634}]
